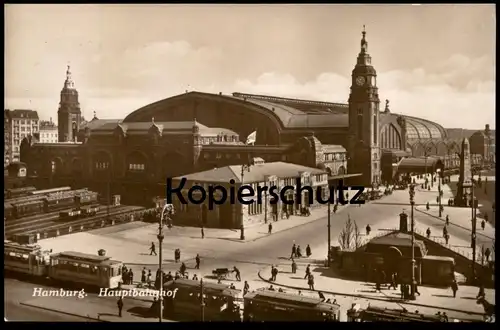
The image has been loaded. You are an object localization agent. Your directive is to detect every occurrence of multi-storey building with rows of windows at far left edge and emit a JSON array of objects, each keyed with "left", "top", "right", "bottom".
[{"left": 4, "top": 109, "right": 40, "bottom": 164}]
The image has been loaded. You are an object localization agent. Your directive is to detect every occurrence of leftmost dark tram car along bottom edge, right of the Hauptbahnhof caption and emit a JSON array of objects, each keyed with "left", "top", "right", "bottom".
[{"left": 163, "top": 279, "right": 241, "bottom": 322}]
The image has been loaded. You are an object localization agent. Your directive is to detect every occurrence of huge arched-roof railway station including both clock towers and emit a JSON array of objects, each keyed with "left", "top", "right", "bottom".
[{"left": 21, "top": 31, "right": 484, "bottom": 208}]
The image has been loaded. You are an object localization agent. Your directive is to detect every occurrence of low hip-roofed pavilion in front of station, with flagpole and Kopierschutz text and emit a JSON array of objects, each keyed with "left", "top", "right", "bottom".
[{"left": 172, "top": 158, "right": 330, "bottom": 229}]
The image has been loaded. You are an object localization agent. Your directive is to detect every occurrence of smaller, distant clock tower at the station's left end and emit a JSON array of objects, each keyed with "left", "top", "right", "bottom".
[{"left": 57, "top": 65, "right": 82, "bottom": 142}]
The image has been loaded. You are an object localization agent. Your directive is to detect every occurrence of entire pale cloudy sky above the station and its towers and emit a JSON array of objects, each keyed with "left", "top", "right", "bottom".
[{"left": 4, "top": 4, "right": 496, "bottom": 129}]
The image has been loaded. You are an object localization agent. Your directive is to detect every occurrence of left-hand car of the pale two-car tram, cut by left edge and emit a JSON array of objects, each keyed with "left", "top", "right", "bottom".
[{"left": 4, "top": 241, "right": 50, "bottom": 276}]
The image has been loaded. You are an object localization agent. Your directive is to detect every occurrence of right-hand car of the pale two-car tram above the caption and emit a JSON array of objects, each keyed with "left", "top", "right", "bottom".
[{"left": 49, "top": 252, "right": 123, "bottom": 289}]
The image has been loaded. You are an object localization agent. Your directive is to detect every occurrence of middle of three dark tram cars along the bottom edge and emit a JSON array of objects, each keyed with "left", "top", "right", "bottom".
[{"left": 243, "top": 290, "right": 340, "bottom": 322}]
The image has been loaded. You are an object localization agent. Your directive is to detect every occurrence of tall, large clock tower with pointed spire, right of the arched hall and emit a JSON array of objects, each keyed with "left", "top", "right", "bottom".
[{"left": 347, "top": 26, "right": 381, "bottom": 186}]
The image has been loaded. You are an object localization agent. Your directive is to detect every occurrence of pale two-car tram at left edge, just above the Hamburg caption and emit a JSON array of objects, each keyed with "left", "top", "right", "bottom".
[{"left": 4, "top": 241, "right": 123, "bottom": 289}]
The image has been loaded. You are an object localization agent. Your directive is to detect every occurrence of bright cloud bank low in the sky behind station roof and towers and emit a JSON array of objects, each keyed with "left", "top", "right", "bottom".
[{"left": 5, "top": 45, "right": 495, "bottom": 129}]
